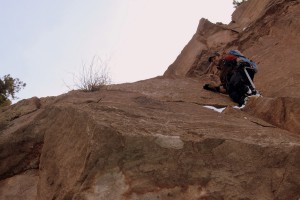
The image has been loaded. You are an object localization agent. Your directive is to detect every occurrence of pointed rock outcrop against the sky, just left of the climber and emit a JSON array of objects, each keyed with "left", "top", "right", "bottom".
[{"left": 164, "top": 19, "right": 237, "bottom": 78}]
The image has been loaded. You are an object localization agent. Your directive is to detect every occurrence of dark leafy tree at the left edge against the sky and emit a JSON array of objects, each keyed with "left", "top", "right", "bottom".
[{"left": 0, "top": 74, "right": 26, "bottom": 106}]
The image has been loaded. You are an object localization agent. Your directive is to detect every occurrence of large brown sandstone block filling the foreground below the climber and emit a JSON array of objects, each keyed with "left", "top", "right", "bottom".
[{"left": 32, "top": 89, "right": 300, "bottom": 199}]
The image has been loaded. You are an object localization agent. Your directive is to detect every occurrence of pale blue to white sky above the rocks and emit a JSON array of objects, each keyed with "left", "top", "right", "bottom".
[{"left": 0, "top": 0, "right": 234, "bottom": 100}]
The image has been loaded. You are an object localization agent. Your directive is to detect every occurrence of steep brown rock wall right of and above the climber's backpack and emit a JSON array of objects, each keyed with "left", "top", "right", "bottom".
[{"left": 227, "top": 0, "right": 300, "bottom": 98}]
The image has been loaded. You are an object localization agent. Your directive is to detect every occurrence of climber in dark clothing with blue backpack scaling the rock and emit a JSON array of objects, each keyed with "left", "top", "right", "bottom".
[{"left": 203, "top": 50, "right": 256, "bottom": 106}]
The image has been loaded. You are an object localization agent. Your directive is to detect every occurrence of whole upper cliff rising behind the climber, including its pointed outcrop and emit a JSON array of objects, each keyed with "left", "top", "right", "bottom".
[{"left": 164, "top": 0, "right": 300, "bottom": 98}]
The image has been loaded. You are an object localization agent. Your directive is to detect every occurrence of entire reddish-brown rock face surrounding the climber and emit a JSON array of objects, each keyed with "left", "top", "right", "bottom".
[{"left": 0, "top": 0, "right": 300, "bottom": 200}]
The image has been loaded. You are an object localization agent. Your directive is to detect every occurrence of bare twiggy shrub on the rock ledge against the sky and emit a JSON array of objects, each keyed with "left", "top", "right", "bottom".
[{"left": 73, "top": 56, "right": 111, "bottom": 92}]
